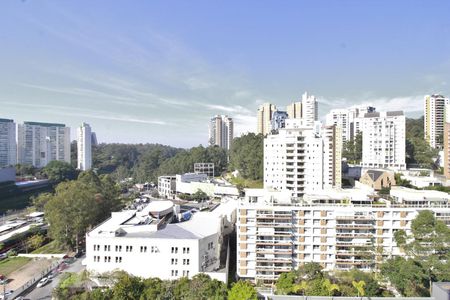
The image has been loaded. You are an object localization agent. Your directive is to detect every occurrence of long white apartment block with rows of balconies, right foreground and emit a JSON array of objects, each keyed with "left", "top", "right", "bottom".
[{"left": 236, "top": 187, "right": 450, "bottom": 285}]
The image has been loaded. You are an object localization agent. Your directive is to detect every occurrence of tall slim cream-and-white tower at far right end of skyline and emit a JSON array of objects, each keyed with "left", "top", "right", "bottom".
[{"left": 424, "top": 94, "right": 449, "bottom": 149}]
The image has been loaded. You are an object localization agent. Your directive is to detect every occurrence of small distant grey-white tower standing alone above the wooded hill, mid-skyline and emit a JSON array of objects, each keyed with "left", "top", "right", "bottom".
[{"left": 209, "top": 115, "right": 233, "bottom": 150}]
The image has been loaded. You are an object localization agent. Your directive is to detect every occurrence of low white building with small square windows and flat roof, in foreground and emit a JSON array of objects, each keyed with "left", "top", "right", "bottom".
[{"left": 85, "top": 200, "right": 237, "bottom": 282}]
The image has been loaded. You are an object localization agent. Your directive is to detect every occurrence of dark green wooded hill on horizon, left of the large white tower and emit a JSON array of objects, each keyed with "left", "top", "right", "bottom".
[{"left": 72, "top": 133, "right": 263, "bottom": 183}]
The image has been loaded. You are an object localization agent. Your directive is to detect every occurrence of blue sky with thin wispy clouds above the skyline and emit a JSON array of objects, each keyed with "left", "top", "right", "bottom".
[{"left": 0, "top": 0, "right": 450, "bottom": 147}]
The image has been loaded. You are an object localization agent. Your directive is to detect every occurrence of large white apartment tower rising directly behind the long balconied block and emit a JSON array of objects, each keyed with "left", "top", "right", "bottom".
[{"left": 264, "top": 119, "right": 342, "bottom": 197}]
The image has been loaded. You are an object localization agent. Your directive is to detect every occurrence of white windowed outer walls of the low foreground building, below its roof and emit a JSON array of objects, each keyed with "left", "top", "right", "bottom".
[{"left": 86, "top": 234, "right": 219, "bottom": 280}]
